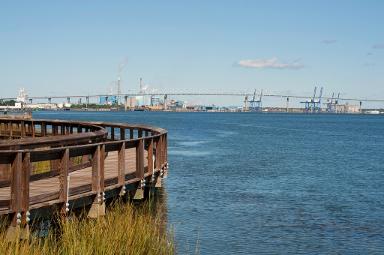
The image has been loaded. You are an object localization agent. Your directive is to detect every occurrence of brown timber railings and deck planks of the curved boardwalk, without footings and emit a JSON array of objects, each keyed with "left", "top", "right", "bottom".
[{"left": 0, "top": 118, "right": 166, "bottom": 219}]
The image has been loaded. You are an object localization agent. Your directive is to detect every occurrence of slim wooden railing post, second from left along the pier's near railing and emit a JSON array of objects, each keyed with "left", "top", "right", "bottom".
[{"left": 59, "top": 148, "right": 69, "bottom": 216}]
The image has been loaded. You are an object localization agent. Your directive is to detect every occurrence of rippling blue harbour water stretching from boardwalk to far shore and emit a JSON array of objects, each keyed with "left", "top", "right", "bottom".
[{"left": 34, "top": 112, "right": 384, "bottom": 254}]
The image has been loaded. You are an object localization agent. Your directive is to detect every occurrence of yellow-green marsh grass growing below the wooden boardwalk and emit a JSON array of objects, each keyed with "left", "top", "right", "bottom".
[{"left": 0, "top": 203, "right": 175, "bottom": 255}]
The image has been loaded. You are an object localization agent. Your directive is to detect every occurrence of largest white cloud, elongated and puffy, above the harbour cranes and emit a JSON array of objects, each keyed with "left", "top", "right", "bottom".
[{"left": 238, "top": 58, "right": 304, "bottom": 69}]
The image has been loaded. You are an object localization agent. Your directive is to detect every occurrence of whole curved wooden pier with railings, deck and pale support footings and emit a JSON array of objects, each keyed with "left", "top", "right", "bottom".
[{"left": 0, "top": 118, "right": 168, "bottom": 239}]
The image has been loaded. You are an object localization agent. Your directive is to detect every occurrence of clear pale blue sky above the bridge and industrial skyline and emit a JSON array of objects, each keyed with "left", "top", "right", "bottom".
[{"left": 0, "top": 0, "right": 384, "bottom": 105}]
